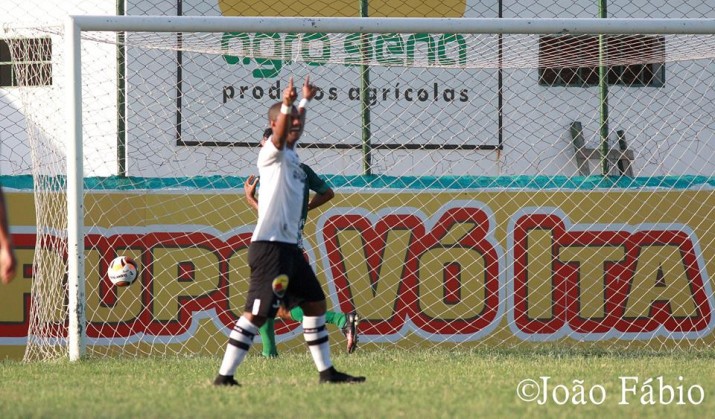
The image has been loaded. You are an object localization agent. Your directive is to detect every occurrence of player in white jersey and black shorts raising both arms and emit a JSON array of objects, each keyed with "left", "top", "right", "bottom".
[{"left": 214, "top": 77, "right": 365, "bottom": 386}]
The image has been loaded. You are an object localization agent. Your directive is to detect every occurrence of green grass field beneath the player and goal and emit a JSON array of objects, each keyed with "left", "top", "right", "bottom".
[{"left": 0, "top": 349, "right": 715, "bottom": 419}]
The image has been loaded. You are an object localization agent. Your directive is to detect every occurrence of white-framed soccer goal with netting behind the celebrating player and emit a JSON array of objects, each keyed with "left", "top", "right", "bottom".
[{"left": 9, "top": 16, "right": 715, "bottom": 360}]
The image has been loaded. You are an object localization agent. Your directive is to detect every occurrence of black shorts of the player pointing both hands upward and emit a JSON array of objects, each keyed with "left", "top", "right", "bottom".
[{"left": 245, "top": 241, "right": 325, "bottom": 318}]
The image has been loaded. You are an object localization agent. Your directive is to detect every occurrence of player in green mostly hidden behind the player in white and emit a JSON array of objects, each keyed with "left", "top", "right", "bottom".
[{"left": 243, "top": 135, "right": 359, "bottom": 358}]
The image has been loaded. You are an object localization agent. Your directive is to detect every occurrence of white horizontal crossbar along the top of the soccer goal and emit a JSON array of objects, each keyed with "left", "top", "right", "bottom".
[{"left": 69, "top": 15, "right": 715, "bottom": 35}]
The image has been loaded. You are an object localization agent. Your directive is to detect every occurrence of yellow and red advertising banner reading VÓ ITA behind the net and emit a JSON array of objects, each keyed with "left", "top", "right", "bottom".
[{"left": 0, "top": 191, "right": 715, "bottom": 356}]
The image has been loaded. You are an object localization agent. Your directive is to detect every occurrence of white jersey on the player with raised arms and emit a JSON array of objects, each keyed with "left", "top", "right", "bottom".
[{"left": 251, "top": 138, "right": 306, "bottom": 244}]
